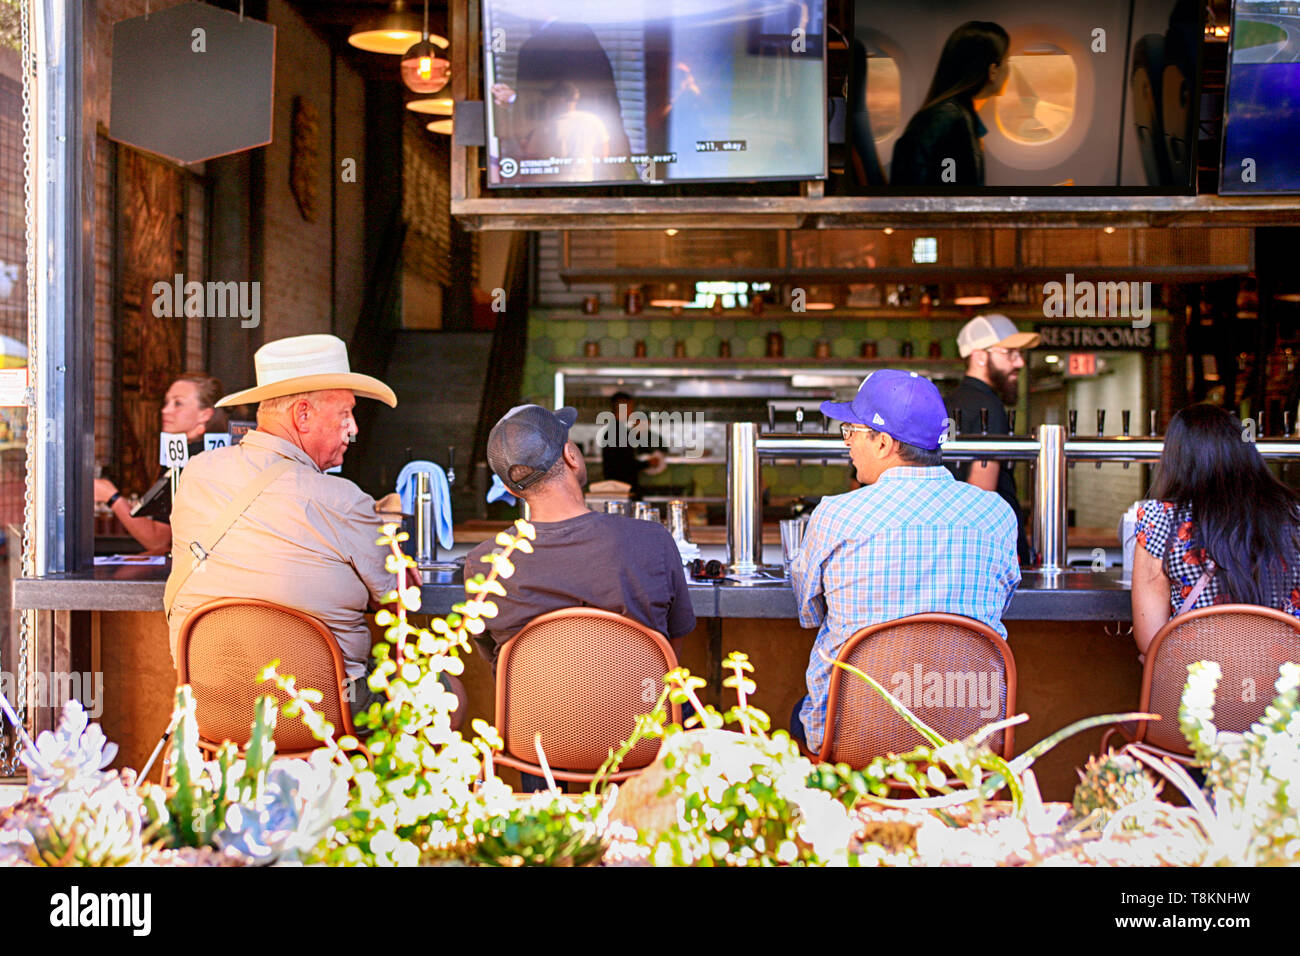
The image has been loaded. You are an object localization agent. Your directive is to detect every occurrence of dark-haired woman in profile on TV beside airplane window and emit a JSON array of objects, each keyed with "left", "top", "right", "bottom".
[{"left": 889, "top": 20, "right": 1011, "bottom": 186}]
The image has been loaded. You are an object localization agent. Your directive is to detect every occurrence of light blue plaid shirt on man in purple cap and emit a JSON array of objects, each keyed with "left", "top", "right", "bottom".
[{"left": 790, "top": 467, "right": 1021, "bottom": 752}]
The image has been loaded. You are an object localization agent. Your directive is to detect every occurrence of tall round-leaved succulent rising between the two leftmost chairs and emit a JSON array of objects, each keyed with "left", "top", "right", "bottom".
[{"left": 263, "top": 522, "right": 534, "bottom": 866}]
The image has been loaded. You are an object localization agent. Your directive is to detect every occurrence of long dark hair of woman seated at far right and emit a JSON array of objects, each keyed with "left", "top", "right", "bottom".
[{"left": 1151, "top": 405, "right": 1300, "bottom": 607}]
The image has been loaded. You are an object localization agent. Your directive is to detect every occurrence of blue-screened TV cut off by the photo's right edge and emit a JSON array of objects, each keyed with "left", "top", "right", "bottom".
[{"left": 1219, "top": 0, "right": 1300, "bottom": 195}]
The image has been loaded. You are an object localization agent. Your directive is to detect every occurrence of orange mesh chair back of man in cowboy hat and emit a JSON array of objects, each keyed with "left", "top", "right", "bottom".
[{"left": 177, "top": 597, "right": 355, "bottom": 756}]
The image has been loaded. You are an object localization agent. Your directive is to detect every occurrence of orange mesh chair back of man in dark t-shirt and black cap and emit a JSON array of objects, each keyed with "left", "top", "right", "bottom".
[{"left": 497, "top": 607, "right": 681, "bottom": 782}]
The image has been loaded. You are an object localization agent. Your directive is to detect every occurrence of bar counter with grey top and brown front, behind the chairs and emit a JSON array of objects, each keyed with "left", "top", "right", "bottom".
[{"left": 13, "top": 544, "right": 1141, "bottom": 800}]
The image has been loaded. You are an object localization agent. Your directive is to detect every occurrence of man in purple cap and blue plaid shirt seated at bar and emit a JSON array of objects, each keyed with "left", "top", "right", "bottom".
[{"left": 790, "top": 368, "right": 1021, "bottom": 752}]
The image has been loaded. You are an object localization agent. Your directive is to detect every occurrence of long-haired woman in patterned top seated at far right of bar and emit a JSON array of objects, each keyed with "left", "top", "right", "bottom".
[{"left": 1132, "top": 405, "right": 1300, "bottom": 653}]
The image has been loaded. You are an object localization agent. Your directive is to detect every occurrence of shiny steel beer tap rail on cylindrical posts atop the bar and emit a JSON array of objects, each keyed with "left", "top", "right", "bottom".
[{"left": 727, "top": 408, "right": 1300, "bottom": 583}]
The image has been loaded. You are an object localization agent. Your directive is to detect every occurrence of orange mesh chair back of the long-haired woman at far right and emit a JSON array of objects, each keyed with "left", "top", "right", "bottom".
[{"left": 1134, "top": 604, "right": 1300, "bottom": 756}]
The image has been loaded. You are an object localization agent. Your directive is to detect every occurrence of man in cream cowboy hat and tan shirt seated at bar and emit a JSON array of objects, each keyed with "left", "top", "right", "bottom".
[{"left": 164, "top": 336, "right": 398, "bottom": 711}]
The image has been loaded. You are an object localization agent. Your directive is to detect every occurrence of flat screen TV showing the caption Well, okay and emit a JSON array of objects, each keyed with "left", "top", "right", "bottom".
[{"left": 482, "top": 0, "right": 827, "bottom": 187}]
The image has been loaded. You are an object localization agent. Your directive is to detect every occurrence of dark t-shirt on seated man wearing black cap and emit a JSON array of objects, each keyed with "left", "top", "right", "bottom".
[{"left": 465, "top": 511, "right": 696, "bottom": 661}]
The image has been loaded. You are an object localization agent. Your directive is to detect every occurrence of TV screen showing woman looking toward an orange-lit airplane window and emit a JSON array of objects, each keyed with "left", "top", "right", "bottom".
[{"left": 848, "top": 0, "right": 1203, "bottom": 195}]
